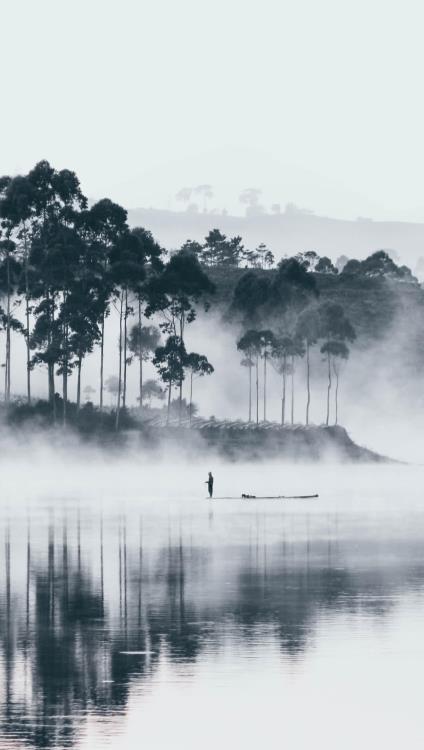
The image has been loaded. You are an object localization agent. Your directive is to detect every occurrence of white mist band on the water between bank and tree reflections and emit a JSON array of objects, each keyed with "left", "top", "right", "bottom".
[{"left": 0, "top": 440, "right": 424, "bottom": 517}]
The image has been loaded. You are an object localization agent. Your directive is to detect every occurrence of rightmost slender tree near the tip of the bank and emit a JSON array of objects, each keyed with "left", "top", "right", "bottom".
[{"left": 319, "top": 302, "right": 356, "bottom": 427}]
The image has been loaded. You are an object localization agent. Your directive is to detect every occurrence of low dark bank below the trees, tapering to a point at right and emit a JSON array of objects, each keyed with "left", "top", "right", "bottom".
[{"left": 0, "top": 403, "right": 392, "bottom": 464}]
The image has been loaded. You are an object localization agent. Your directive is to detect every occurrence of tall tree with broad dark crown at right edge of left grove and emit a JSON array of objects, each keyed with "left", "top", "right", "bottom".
[{"left": 146, "top": 250, "right": 215, "bottom": 420}]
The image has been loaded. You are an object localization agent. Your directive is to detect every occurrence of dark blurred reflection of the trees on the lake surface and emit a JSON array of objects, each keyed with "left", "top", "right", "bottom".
[{"left": 0, "top": 507, "right": 424, "bottom": 748}]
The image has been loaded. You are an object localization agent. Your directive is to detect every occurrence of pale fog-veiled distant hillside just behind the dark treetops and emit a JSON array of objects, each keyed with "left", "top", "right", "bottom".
[{"left": 128, "top": 208, "right": 424, "bottom": 270}]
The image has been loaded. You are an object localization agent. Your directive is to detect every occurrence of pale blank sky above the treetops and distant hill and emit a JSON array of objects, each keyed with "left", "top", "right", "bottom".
[{"left": 0, "top": 0, "right": 424, "bottom": 221}]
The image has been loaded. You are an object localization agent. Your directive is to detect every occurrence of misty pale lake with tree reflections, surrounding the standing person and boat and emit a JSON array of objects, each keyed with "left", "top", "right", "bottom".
[{"left": 0, "top": 457, "right": 424, "bottom": 750}]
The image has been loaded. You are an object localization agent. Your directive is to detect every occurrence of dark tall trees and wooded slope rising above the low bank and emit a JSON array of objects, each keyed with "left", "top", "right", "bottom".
[{"left": 0, "top": 161, "right": 424, "bottom": 458}]
